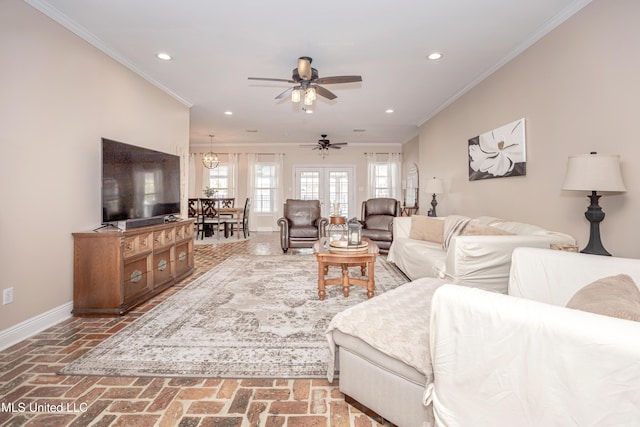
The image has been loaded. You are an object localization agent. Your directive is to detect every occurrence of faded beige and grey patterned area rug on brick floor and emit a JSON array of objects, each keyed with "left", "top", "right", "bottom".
[{"left": 61, "top": 255, "right": 407, "bottom": 378}]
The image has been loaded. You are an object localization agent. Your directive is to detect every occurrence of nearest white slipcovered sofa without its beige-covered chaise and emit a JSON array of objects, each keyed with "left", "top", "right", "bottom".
[{"left": 427, "top": 248, "right": 640, "bottom": 427}]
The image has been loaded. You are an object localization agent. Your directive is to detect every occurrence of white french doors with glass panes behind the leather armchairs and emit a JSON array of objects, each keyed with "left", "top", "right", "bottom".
[{"left": 294, "top": 166, "right": 356, "bottom": 218}]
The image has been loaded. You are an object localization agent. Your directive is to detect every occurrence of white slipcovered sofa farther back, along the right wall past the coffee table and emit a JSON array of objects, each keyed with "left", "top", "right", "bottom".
[{"left": 387, "top": 215, "right": 576, "bottom": 293}]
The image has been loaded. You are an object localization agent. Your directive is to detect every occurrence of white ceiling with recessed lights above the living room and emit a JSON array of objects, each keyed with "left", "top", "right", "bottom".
[{"left": 25, "top": 0, "right": 590, "bottom": 146}]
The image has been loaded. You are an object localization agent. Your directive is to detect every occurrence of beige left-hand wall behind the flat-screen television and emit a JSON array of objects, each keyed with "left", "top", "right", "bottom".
[{"left": 0, "top": 0, "right": 189, "bottom": 335}]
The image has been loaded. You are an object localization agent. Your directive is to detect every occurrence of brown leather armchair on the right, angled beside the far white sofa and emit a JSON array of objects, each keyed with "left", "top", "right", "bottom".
[{"left": 360, "top": 198, "right": 400, "bottom": 252}]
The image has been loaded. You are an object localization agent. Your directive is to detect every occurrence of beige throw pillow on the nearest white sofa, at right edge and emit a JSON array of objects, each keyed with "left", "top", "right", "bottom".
[{"left": 567, "top": 274, "right": 640, "bottom": 322}]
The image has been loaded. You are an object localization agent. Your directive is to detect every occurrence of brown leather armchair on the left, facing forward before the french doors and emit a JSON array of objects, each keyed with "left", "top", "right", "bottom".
[{"left": 278, "top": 199, "right": 329, "bottom": 252}]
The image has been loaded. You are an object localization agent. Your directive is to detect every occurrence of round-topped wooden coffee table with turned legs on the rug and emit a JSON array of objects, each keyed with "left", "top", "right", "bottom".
[{"left": 313, "top": 237, "right": 379, "bottom": 300}]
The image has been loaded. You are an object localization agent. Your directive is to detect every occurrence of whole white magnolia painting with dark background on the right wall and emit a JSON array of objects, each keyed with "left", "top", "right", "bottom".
[{"left": 469, "top": 119, "right": 527, "bottom": 181}]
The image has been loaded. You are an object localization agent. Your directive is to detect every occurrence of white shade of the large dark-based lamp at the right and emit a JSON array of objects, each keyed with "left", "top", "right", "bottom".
[{"left": 562, "top": 154, "right": 627, "bottom": 192}]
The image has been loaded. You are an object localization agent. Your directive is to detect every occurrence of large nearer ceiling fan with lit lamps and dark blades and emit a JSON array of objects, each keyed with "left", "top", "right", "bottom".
[{"left": 249, "top": 56, "right": 362, "bottom": 105}]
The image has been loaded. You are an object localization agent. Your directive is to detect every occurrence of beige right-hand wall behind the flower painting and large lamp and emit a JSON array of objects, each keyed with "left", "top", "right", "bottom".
[{"left": 420, "top": 0, "right": 640, "bottom": 258}]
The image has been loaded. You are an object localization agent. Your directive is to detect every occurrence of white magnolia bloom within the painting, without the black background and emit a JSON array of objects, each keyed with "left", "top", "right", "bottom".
[{"left": 469, "top": 120, "right": 525, "bottom": 176}]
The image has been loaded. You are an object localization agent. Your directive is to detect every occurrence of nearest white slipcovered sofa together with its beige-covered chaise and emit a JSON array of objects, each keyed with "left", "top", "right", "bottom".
[{"left": 327, "top": 248, "right": 640, "bottom": 427}]
